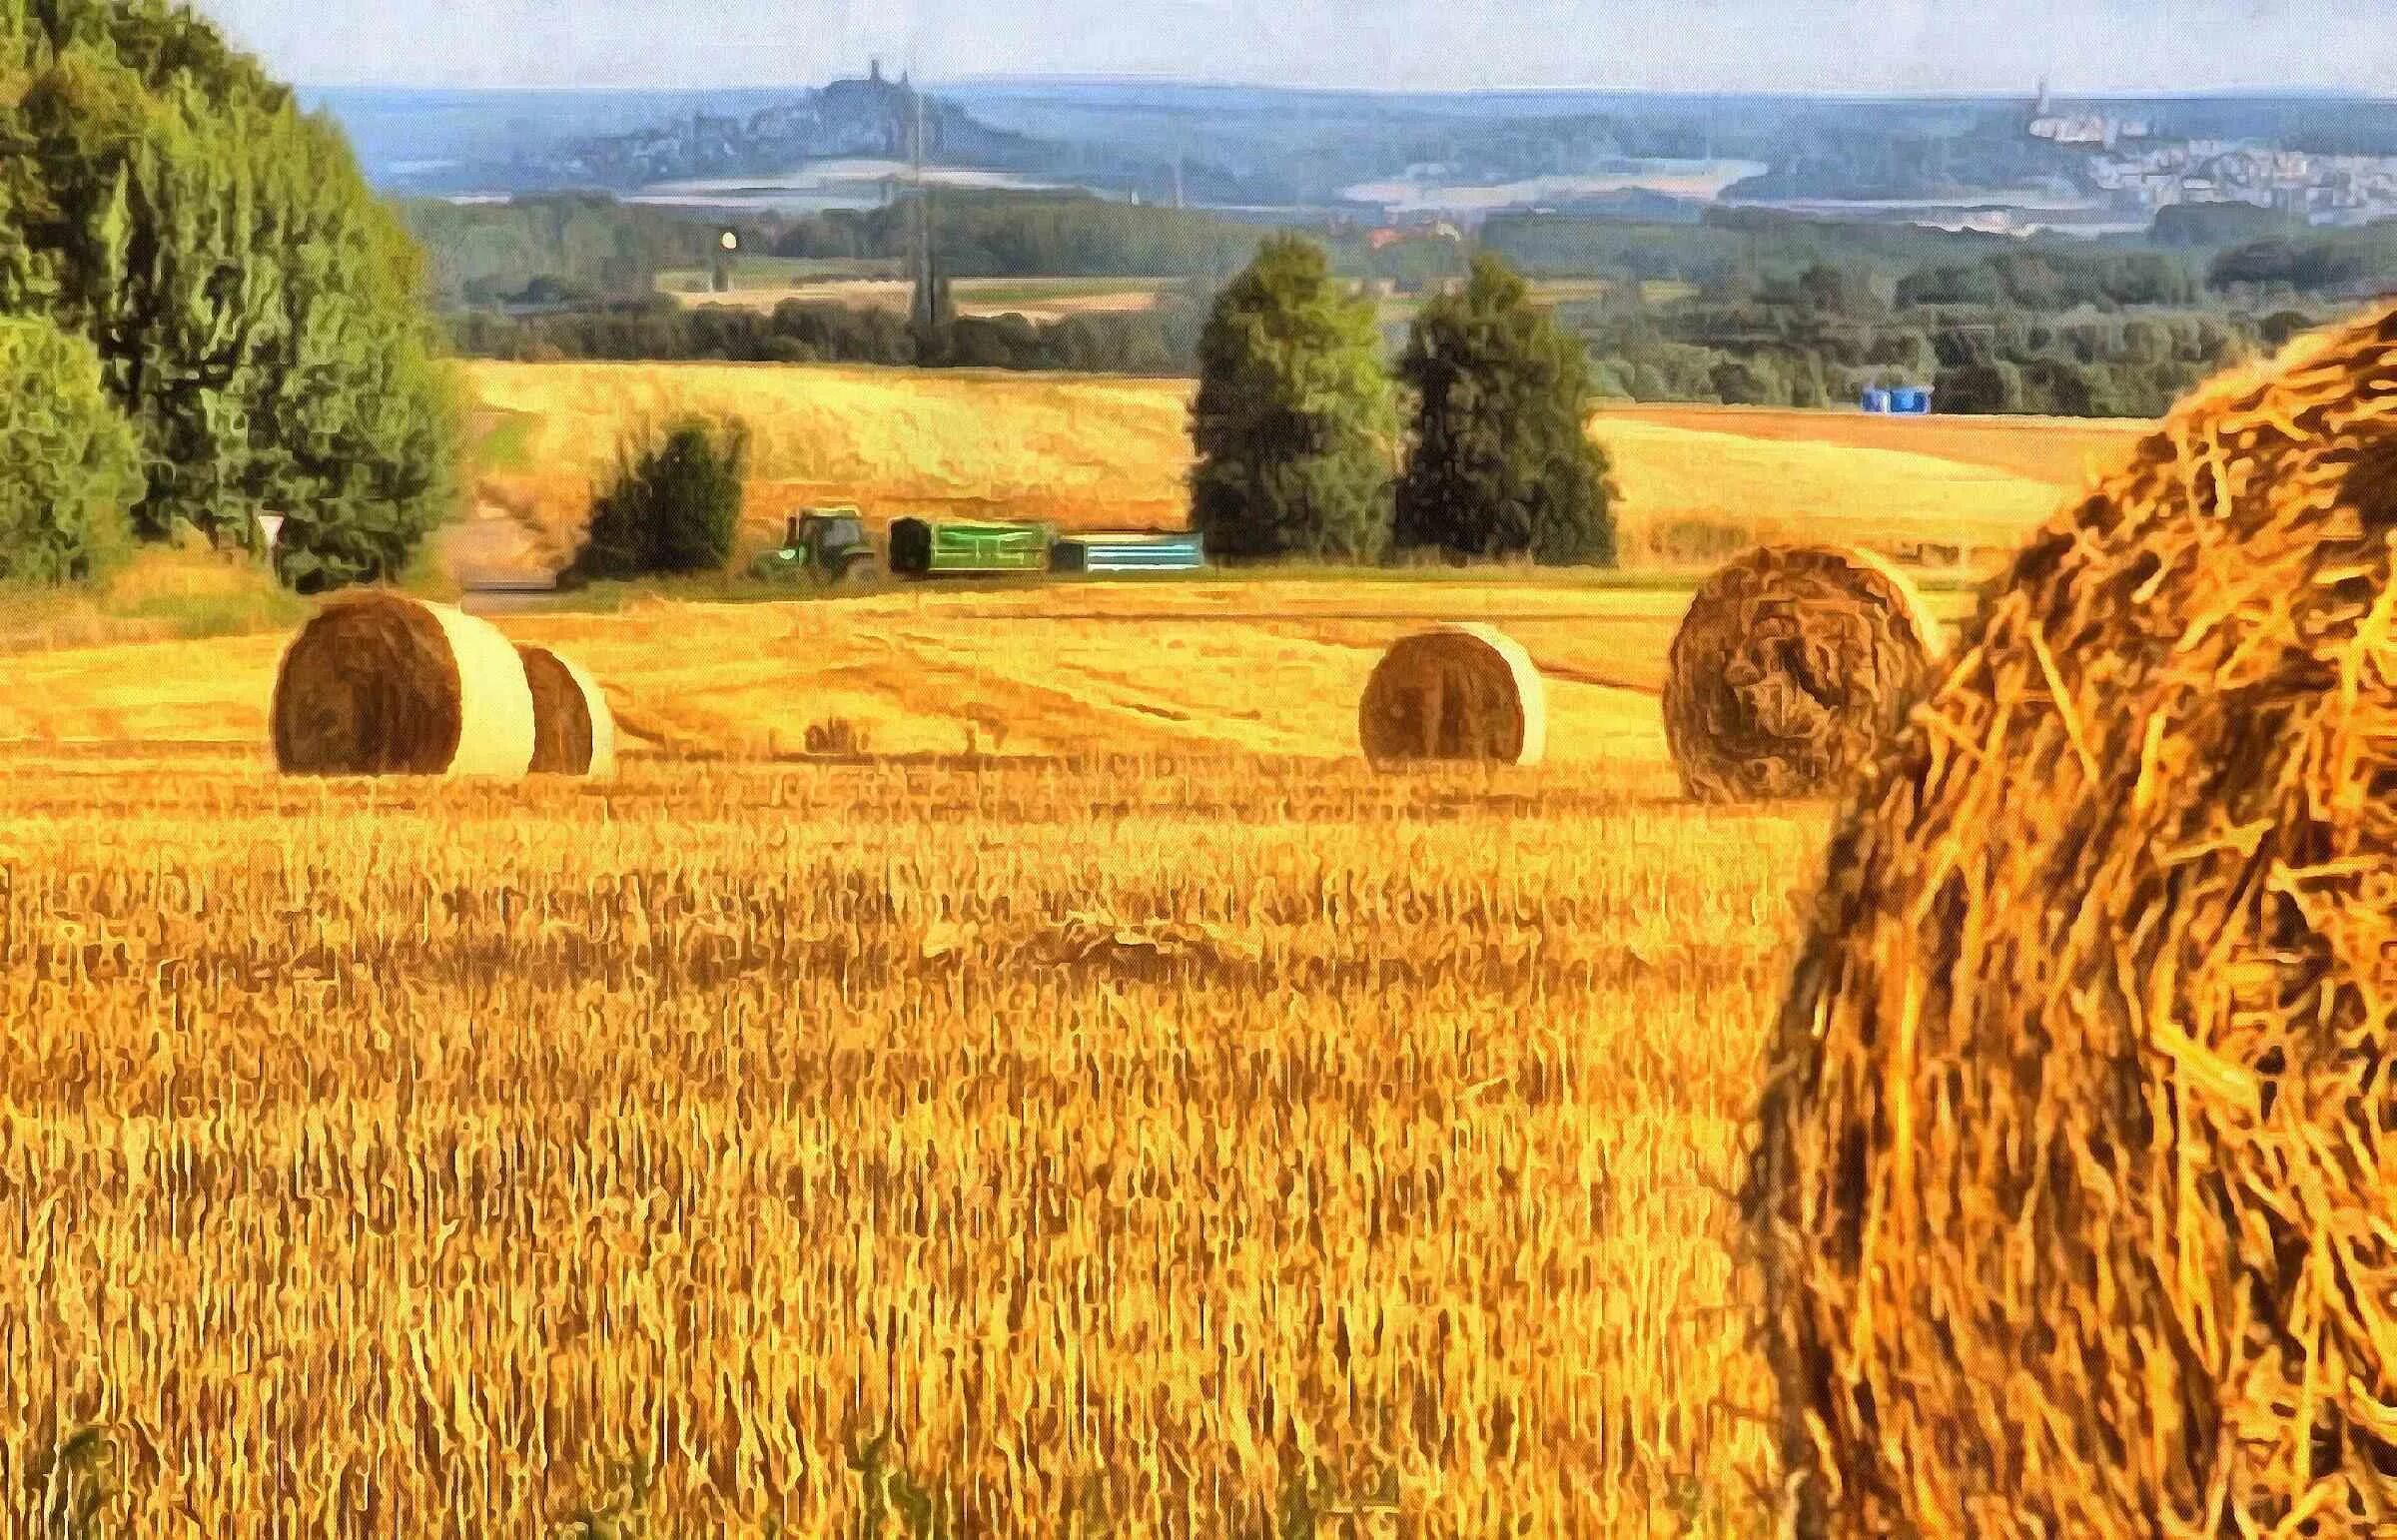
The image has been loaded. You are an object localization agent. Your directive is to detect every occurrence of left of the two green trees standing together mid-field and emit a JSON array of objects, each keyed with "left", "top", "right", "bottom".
[{"left": 1192, "top": 238, "right": 1397, "bottom": 561}]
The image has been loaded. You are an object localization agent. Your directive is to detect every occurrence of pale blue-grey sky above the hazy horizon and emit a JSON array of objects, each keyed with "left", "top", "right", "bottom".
[{"left": 199, "top": 0, "right": 2397, "bottom": 94}]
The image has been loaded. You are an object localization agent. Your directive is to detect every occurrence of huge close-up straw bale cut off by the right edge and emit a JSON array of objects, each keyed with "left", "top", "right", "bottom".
[{"left": 1745, "top": 310, "right": 2397, "bottom": 1535}]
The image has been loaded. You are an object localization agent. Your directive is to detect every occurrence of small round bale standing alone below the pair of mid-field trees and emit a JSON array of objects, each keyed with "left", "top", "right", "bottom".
[{"left": 1356, "top": 623, "right": 1548, "bottom": 765}]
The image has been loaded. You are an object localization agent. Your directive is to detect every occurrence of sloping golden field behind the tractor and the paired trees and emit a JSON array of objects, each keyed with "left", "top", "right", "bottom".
[{"left": 467, "top": 363, "right": 2140, "bottom": 580}]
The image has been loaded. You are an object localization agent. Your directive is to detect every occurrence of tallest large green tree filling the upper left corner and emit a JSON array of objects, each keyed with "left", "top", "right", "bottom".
[{"left": 0, "top": 0, "right": 457, "bottom": 587}]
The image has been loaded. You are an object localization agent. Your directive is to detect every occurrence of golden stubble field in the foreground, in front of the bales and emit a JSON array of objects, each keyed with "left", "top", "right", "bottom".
[{"left": 0, "top": 744, "right": 1824, "bottom": 1535}]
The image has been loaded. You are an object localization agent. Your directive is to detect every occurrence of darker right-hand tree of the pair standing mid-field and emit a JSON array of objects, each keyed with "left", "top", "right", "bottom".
[{"left": 1397, "top": 257, "right": 1616, "bottom": 563}]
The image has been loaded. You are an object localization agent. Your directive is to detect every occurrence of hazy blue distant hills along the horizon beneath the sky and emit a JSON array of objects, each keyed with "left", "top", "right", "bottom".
[{"left": 312, "top": 70, "right": 2397, "bottom": 233}]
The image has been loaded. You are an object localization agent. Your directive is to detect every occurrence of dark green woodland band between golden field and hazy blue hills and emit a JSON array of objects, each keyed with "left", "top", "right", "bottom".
[{"left": 407, "top": 192, "right": 2397, "bottom": 415}]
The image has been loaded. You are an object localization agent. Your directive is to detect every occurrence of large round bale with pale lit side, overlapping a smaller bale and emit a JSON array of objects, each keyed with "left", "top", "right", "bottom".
[{"left": 274, "top": 592, "right": 532, "bottom": 775}]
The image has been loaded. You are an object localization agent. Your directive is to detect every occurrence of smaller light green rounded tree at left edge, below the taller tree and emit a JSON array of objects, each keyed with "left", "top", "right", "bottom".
[{"left": 0, "top": 317, "right": 142, "bottom": 583}]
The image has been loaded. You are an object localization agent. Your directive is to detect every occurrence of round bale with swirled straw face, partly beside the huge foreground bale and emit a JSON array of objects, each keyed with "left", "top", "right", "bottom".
[{"left": 1664, "top": 544, "right": 1942, "bottom": 801}]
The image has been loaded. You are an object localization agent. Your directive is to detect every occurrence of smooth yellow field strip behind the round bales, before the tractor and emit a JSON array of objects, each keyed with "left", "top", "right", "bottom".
[{"left": 0, "top": 573, "right": 1968, "bottom": 770}]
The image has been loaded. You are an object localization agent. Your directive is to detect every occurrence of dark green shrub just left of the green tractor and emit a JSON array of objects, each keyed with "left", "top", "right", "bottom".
[{"left": 575, "top": 417, "right": 748, "bottom": 578}]
